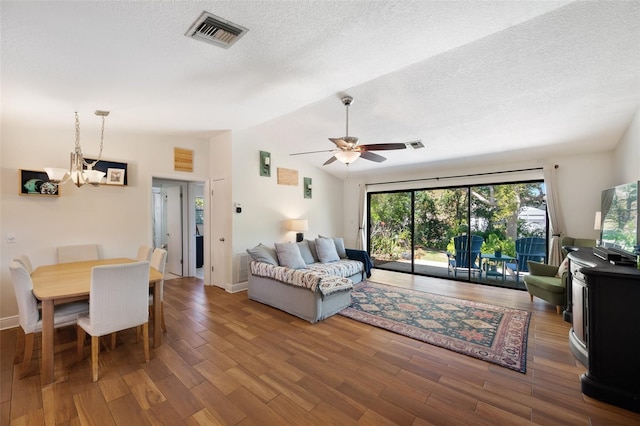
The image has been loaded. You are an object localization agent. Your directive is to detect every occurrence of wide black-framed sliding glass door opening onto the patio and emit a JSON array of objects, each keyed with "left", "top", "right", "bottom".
[{"left": 368, "top": 182, "right": 547, "bottom": 288}]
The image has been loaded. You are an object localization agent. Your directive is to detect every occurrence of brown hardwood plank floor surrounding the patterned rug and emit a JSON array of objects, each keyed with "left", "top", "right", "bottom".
[{"left": 0, "top": 270, "right": 640, "bottom": 425}]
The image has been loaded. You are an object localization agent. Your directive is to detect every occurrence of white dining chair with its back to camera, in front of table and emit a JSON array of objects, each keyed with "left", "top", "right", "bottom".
[{"left": 77, "top": 261, "right": 149, "bottom": 382}]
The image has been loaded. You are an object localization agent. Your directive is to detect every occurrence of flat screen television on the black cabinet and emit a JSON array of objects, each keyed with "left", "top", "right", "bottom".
[{"left": 600, "top": 181, "right": 640, "bottom": 258}]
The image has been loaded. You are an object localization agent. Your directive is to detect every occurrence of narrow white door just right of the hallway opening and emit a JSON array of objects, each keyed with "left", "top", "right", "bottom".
[{"left": 211, "top": 179, "right": 229, "bottom": 288}]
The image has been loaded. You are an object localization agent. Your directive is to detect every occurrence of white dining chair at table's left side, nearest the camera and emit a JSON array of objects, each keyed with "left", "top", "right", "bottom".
[{"left": 9, "top": 261, "right": 89, "bottom": 377}]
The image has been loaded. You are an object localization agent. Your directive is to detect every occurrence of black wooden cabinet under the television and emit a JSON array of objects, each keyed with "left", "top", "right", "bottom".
[{"left": 568, "top": 248, "right": 640, "bottom": 412}]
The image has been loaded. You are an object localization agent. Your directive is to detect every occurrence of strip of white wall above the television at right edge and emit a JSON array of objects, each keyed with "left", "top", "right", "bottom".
[{"left": 609, "top": 109, "right": 640, "bottom": 186}]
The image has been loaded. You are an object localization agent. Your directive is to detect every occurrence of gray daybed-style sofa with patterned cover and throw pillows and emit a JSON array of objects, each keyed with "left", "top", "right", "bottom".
[{"left": 247, "top": 239, "right": 365, "bottom": 323}]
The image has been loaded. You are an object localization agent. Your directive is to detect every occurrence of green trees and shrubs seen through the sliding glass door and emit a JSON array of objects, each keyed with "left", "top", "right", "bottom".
[{"left": 369, "top": 182, "right": 546, "bottom": 264}]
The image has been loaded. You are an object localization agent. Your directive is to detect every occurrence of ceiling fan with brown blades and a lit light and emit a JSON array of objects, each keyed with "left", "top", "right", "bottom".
[{"left": 291, "top": 96, "right": 419, "bottom": 166}]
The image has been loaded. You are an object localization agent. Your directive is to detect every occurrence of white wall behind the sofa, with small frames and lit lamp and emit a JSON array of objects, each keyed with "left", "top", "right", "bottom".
[{"left": 232, "top": 126, "right": 344, "bottom": 253}]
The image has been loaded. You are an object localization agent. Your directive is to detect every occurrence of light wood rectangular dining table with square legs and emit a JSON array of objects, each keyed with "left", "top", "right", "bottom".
[{"left": 31, "top": 258, "right": 163, "bottom": 385}]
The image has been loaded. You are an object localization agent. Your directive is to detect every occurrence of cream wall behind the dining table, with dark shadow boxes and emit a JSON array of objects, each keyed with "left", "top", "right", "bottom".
[{"left": 0, "top": 123, "right": 209, "bottom": 319}]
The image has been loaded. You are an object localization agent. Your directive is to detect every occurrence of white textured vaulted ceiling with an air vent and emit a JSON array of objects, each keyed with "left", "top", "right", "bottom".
[{"left": 0, "top": 1, "right": 640, "bottom": 176}]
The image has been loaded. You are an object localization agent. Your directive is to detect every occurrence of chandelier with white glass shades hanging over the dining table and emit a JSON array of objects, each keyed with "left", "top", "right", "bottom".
[{"left": 44, "top": 110, "right": 109, "bottom": 187}]
